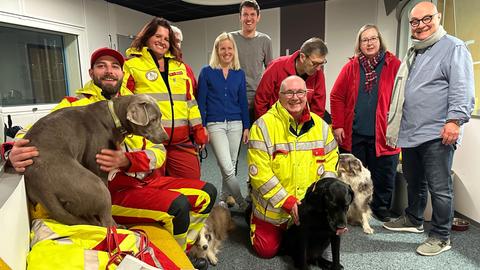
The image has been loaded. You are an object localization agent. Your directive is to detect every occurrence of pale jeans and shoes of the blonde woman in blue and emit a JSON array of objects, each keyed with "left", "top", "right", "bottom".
[{"left": 207, "top": 121, "right": 245, "bottom": 205}]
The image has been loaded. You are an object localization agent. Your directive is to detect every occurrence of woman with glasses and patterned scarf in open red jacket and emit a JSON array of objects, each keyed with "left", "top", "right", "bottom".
[{"left": 330, "top": 25, "right": 400, "bottom": 221}]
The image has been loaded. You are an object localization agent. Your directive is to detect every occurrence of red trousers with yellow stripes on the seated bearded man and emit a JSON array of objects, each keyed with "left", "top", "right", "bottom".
[{"left": 108, "top": 170, "right": 217, "bottom": 250}]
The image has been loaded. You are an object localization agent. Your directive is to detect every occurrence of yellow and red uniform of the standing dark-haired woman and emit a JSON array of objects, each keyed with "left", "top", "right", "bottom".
[{"left": 123, "top": 47, "right": 207, "bottom": 179}]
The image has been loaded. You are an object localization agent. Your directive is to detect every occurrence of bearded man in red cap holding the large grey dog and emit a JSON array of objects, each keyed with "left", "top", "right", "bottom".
[{"left": 3, "top": 48, "right": 217, "bottom": 269}]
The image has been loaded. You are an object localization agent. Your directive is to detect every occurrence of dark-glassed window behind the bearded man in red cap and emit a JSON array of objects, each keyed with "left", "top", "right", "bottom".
[{"left": 0, "top": 24, "right": 81, "bottom": 107}]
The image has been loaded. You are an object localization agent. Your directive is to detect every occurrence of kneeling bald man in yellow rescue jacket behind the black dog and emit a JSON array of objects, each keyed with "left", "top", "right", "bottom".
[{"left": 247, "top": 76, "right": 338, "bottom": 258}]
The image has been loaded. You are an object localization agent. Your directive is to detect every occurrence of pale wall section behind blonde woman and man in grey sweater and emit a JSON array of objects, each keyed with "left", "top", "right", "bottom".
[{"left": 176, "top": 8, "right": 280, "bottom": 76}]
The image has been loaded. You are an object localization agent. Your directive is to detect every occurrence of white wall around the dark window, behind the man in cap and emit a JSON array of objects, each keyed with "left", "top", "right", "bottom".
[{"left": 0, "top": 0, "right": 152, "bottom": 126}]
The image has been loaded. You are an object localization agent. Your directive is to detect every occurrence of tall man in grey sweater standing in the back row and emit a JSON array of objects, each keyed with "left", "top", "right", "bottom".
[{"left": 231, "top": 0, "right": 272, "bottom": 123}]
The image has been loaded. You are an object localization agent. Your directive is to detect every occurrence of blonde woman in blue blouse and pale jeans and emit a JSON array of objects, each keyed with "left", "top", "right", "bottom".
[{"left": 197, "top": 32, "right": 250, "bottom": 210}]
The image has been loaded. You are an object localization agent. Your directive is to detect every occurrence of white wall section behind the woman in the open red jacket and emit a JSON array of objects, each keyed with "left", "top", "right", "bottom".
[{"left": 325, "top": 0, "right": 397, "bottom": 111}]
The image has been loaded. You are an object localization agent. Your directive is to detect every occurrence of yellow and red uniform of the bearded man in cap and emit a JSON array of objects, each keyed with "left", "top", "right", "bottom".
[{"left": 20, "top": 81, "right": 216, "bottom": 249}]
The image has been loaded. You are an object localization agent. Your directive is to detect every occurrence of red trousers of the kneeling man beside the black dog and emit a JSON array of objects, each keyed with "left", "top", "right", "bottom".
[{"left": 250, "top": 214, "right": 287, "bottom": 259}]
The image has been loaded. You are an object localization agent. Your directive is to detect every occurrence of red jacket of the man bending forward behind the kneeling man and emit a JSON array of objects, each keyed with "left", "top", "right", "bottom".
[{"left": 251, "top": 51, "right": 326, "bottom": 119}]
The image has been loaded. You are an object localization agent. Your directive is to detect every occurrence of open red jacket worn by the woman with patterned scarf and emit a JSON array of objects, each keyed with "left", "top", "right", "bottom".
[{"left": 330, "top": 51, "right": 400, "bottom": 157}]
